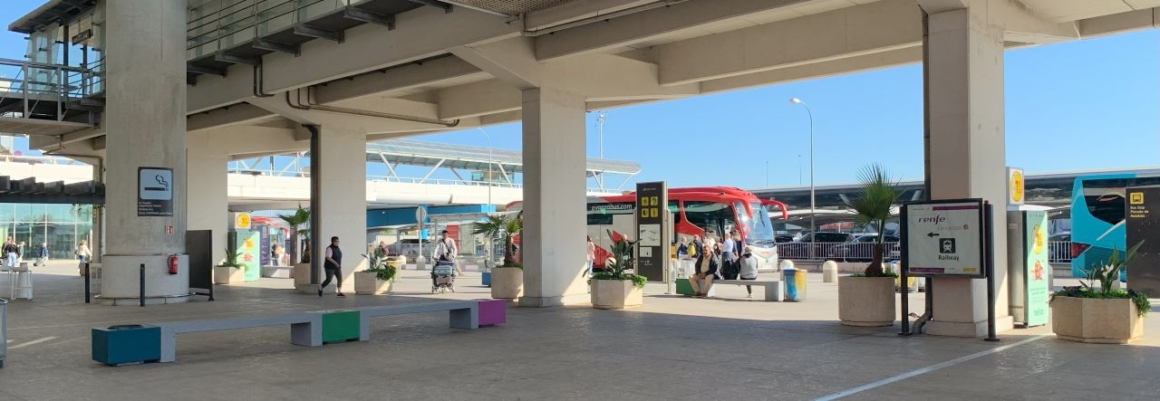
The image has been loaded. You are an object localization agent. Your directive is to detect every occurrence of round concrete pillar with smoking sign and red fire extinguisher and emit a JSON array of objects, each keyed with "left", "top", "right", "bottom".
[{"left": 101, "top": 0, "right": 189, "bottom": 302}]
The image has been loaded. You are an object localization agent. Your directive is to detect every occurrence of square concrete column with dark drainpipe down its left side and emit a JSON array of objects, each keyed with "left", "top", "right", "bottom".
[{"left": 310, "top": 125, "right": 367, "bottom": 293}]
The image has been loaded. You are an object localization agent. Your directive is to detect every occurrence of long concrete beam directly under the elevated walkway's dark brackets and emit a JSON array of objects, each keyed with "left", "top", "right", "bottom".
[{"left": 188, "top": 7, "right": 521, "bottom": 112}]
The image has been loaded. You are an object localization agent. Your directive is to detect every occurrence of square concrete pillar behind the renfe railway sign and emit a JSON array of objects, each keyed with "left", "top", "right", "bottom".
[{"left": 926, "top": 1, "right": 1013, "bottom": 337}]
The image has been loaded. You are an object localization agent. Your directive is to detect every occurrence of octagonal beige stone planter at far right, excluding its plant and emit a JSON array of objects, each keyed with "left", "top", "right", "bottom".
[{"left": 1051, "top": 297, "right": 1144, "bottom": 344}]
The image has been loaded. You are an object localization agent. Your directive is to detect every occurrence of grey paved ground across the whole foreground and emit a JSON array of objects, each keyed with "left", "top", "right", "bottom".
[{"left": 0, "top": 258, "right": 1160, "bottom": 401}]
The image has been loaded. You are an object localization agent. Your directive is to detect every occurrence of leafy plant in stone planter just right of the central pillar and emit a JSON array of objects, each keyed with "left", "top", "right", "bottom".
[{"left": 590, "top": 231, "right": 647, "bottom": 309}]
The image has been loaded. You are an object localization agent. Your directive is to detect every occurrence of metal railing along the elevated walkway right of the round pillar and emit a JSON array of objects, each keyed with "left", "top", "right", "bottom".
[{"left": 186, "top": 0, "right": 365, "bottom": 59}]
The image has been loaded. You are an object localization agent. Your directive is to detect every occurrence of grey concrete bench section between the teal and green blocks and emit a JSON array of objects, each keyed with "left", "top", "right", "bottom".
[{"left": 157, "top": 313, "right": 322, "bottom": 363}]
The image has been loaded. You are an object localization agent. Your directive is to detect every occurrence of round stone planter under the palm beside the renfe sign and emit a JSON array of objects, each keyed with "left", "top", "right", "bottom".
[{"left": 838, "top": 277, "right": 896, "bottom": 327}]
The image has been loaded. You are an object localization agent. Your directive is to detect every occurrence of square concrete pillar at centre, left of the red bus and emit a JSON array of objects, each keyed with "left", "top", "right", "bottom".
[{"left": 520, "top": 88, "right": 588, "bottom": 307}]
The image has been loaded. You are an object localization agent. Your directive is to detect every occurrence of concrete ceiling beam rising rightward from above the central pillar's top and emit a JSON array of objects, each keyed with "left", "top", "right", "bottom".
[{"left": 536, "top": 0, "right": 807, "bottom": 61}]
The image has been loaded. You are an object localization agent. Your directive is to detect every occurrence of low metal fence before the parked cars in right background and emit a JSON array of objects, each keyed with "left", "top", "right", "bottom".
[{"left": 777, "top": 241, "right": 1072, "bottom": 263}]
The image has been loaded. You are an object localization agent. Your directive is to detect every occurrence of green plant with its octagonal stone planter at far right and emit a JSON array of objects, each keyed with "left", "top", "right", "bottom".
[{"left": 1051, "top": 241, "right": 1152, "bottom": 344}]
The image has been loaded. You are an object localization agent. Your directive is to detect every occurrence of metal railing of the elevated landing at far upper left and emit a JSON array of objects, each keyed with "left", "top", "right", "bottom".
[{"left": 0, "top": 58, "right": 103, "bottom": 121}]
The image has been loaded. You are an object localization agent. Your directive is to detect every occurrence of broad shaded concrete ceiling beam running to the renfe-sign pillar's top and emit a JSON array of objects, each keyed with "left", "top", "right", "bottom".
[{"left": 652, "top": 0, "right": 922, "bottom": 86}]
